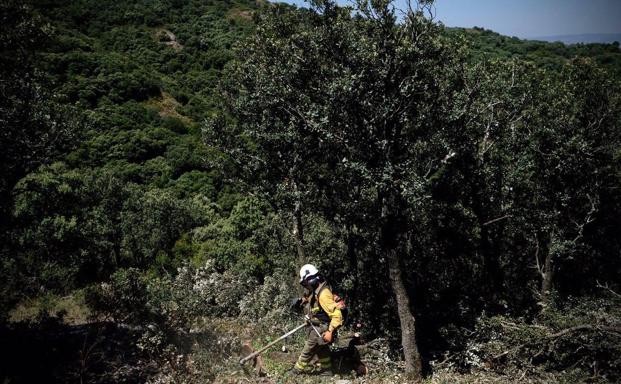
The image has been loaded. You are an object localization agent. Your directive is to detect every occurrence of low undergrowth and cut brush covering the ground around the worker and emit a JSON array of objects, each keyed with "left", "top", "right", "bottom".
[{"left": 0, "top": 266, "right": 621, "bottom": 384}]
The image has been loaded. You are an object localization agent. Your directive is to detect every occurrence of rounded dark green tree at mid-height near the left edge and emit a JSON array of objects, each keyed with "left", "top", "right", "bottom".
[{"left": 14, "top": 163, "right": 112, "bottom": 292}]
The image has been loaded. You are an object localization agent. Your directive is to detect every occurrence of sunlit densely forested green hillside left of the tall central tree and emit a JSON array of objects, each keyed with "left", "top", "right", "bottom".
[{"left": 3, "top": 1, "right": 255, "bottom": 298}]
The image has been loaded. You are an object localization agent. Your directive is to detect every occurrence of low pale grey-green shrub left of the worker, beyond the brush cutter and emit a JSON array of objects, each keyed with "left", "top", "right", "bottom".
[{"left": 86, "top": 262, "right": 257, "bottom": 333}]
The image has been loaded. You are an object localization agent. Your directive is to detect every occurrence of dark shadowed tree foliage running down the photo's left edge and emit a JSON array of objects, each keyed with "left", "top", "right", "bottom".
[{"left": 0, "top": 1, "right": 81, "bottom": 292}]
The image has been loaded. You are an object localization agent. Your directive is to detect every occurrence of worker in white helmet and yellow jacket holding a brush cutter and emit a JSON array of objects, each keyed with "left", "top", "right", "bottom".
[{"left": 293, "top": 264, "right": 343, "bottom": 374}]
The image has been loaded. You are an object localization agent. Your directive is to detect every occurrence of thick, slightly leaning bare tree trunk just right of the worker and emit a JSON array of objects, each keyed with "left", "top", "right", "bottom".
[{"left": 380, "top": 190, "right": 422, "bottom": 379}]
